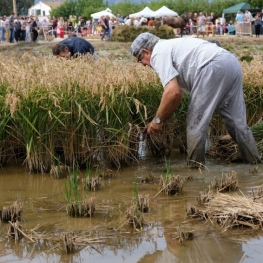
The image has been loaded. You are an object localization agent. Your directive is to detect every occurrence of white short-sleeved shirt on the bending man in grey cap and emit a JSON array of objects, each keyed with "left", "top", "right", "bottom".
[{"left": 150, "top": 37, "right": 228, "bottom": 93}]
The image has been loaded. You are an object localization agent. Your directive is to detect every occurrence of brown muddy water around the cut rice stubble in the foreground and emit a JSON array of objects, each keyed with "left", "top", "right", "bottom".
[{"left": 0, "top": 153, "right": 263, "bottom": 263}]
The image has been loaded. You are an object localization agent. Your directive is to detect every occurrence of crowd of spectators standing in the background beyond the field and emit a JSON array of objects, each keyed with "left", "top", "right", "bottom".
[{"left": 0, "top": 10, "right": 263, "bottom": 43}]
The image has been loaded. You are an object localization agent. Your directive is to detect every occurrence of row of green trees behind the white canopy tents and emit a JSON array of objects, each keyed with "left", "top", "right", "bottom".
[{"left": 49, "top": 0, "right": 258, "bottom": 22}]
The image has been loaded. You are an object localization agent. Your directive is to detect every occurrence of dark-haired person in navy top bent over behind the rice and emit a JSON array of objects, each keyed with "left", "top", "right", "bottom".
[{"left": 52, "top": 37, "right": 95, "bottom": 57}]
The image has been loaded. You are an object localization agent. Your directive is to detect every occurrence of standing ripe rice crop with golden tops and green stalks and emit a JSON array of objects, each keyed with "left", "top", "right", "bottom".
[{"left": 0, "top": 38, "right": 263, "bottom": 173}]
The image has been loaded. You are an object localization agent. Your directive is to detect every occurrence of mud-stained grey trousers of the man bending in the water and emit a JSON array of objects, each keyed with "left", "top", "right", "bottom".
[{"left": 187, "top": 52, "right": 260, "bottom": 165}]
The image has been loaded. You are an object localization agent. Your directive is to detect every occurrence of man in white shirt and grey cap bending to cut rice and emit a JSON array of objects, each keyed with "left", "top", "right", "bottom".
[{"left": 130, "top": 32, "right": 261, "bottom": 167}]
